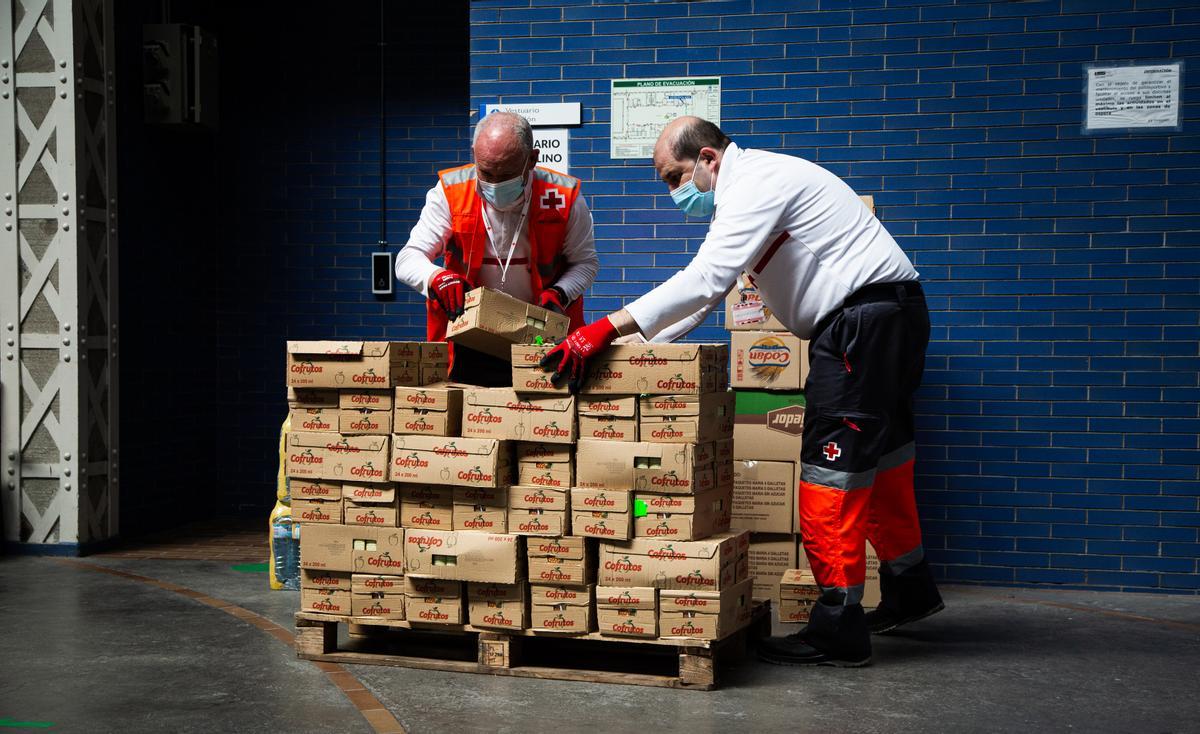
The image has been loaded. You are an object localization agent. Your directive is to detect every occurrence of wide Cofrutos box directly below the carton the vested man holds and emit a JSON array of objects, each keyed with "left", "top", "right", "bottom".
[{"left": 462, "top": 387, "right": 576, "bottom": 444}]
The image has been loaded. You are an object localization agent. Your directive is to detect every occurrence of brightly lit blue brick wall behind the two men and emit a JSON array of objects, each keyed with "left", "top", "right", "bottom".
[{"left": 470, "top": 0, "right": 1200, "bottom": 592}]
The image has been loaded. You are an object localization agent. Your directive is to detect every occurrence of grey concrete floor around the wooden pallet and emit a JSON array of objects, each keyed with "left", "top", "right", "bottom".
[{"left": 0, "top": 556, "right": 1200, "bottom": 734}]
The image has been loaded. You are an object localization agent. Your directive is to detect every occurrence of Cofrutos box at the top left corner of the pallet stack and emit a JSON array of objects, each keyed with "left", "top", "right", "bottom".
[{"left": 287, "top": 342, "right": 404, "bottom": 390}]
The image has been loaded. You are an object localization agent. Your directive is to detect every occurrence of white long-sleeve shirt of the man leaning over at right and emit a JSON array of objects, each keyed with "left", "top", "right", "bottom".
[{"left": 625, "top": 143, "right": 917, "bottom": 341}]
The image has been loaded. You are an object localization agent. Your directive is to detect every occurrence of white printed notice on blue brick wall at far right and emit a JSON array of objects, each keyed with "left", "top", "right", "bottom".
[{"left": 1084, "top": 61, "right": 1183, "bottom": 133}]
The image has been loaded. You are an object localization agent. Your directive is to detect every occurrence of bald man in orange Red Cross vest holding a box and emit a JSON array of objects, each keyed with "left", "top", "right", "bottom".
[{"left": 396, "top": 112, "right": 600, "bottom": 386}]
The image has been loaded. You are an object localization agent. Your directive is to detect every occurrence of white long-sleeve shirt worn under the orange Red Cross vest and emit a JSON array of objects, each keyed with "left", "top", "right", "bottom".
[{"left": 396, "top": 172, "right": 600, "bottom": 303}]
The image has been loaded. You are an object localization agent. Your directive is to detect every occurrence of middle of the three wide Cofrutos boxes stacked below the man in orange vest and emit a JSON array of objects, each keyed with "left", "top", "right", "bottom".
[{"left": 390, "top": 434, "right": 512, "bottom": 487}]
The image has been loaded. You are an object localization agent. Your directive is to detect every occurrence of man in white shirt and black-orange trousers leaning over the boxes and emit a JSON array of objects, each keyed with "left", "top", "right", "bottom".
[{"left": 542, "top": 118, "right": 942, "bottom": 667}]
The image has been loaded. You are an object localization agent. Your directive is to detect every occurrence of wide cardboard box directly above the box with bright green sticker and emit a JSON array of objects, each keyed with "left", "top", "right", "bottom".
[{"left": 575, "top": 440, "right": 715, "bottom": 494}]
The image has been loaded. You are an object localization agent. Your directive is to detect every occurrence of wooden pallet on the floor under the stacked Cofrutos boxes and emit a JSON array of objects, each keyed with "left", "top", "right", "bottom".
[{"left": 295, "top": 604, "right": 770, "bottom": 691}]
